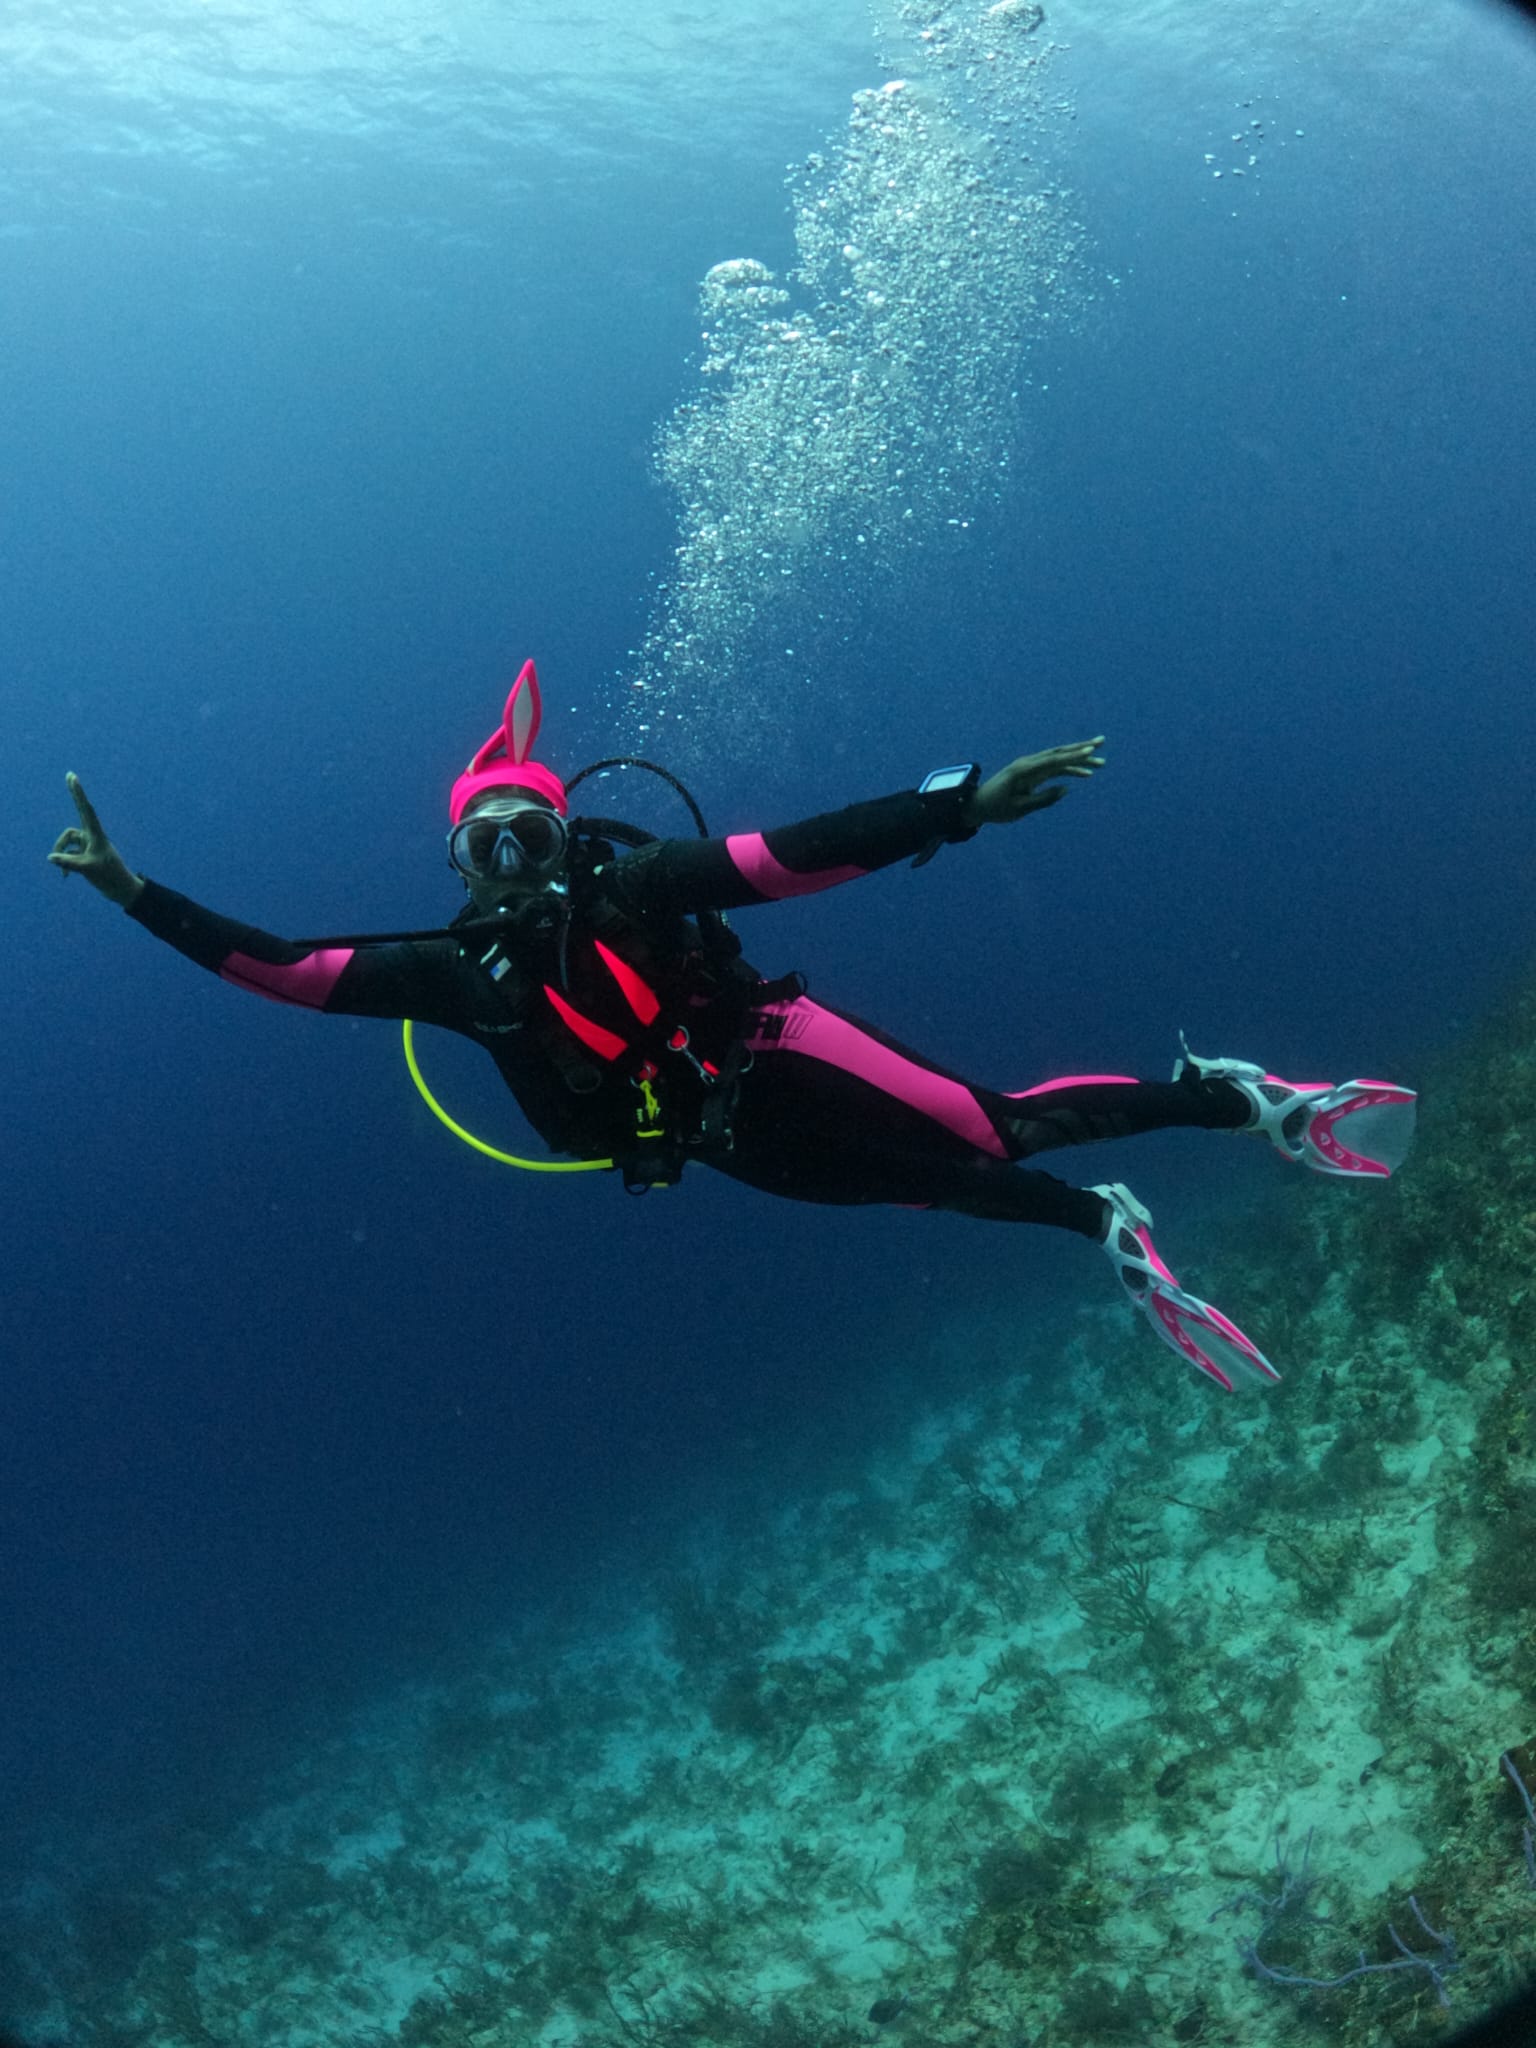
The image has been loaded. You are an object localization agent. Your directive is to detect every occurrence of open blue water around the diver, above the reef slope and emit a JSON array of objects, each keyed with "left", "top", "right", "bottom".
[{"left": 0, "top": 0, "right": 1536, "bottom": 2015}]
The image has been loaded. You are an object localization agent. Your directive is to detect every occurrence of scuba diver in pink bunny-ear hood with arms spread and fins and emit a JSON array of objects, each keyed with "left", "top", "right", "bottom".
[{"left": 49, "top": 662, "right": 1415, "bottom": 1391}]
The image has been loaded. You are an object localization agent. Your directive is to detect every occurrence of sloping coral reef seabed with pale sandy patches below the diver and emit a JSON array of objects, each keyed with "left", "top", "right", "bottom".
[{"left": 15, "top": 966, "right": 1536, "bottom": 2048}]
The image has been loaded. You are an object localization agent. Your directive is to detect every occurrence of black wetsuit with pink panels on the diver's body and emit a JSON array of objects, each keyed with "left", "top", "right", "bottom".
[{"left": 129, "top": 791, "right": 1249, "bottom": 1237}]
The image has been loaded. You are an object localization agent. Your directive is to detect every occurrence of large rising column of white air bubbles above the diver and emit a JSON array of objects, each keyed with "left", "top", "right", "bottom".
[{"left": 621, "top": 0, "right": 1085, "bottom": 745}]
